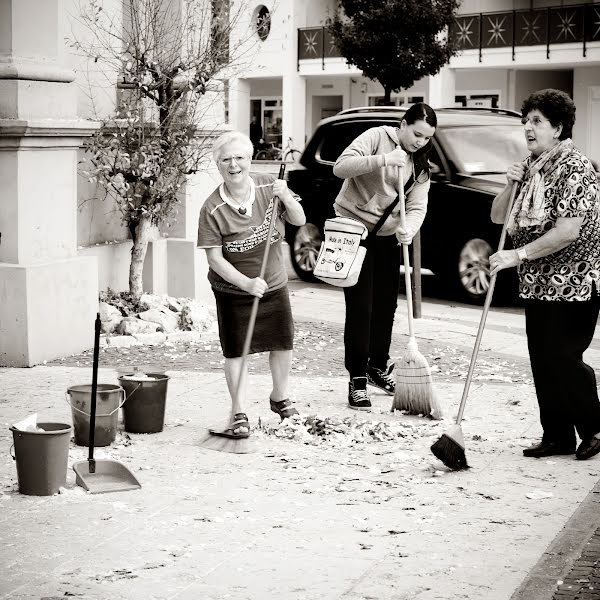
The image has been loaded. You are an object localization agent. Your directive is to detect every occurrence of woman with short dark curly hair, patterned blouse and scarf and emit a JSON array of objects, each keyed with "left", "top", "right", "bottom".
[{"left": 490, "top": 89, "right": 600, "bottom": 460}]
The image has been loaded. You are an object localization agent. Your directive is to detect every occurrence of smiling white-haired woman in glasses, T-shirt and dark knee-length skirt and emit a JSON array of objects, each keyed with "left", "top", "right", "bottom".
[{"left": 198, "top": 132, "right": 305, "bottom": 438}]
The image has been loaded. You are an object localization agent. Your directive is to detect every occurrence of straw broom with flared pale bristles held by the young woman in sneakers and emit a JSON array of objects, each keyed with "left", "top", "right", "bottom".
[{"left": 392, "top": 174, "right": 442, "bottom": 419}]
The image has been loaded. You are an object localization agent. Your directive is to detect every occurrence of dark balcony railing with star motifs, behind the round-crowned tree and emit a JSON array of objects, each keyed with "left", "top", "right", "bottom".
[{"left": 298, "top": 2, "right": 600, "bottom": 68}]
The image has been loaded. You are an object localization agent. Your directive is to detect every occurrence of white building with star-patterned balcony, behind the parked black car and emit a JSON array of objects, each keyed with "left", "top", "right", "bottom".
[{"left": 230, "top": 0, "right": 600, "bottom": 160}]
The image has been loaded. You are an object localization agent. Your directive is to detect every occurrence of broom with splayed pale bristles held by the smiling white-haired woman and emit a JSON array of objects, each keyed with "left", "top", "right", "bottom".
[{"left": 200, "top": 163, "right": 285, "bottom": 454}]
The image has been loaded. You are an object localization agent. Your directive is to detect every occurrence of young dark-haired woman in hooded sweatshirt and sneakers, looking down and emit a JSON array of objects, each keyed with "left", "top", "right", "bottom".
[{"left": 333, "top": 102, "right": 437, "bottom": 410}]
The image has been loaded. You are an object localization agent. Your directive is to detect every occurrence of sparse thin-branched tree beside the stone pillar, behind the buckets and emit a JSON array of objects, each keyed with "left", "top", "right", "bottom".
[{"left": 71, "top": 0, "right": 258, "bottom": 299}]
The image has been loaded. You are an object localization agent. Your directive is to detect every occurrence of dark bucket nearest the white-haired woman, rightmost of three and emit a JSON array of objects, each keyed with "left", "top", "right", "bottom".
[{"left": 119, "top": 373, "right": 169, "bottom": 433}]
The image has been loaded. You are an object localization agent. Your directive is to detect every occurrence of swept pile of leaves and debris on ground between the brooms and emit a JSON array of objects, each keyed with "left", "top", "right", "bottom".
[{"left": 257, "top": 415, "right": 436, "bottom": 447}]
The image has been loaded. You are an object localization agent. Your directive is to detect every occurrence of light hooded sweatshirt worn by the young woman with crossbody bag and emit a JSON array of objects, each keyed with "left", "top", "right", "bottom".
[{"left": 333, "top": 125, "right": 430, "bottom": 236}]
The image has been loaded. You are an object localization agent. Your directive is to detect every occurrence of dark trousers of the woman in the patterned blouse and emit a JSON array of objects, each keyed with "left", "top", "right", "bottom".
[{"left": 525, "top": 294, "right": 600, "bottom": 446}]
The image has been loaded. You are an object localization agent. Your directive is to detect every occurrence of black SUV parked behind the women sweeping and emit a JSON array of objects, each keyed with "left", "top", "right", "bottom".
[{"left": 286, "top": 107, "right": 528, "bottom": 303}]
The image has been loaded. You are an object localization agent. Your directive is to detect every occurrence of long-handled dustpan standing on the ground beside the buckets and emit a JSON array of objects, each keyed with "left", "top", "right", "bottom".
[{"left": 73, "top": 313, "right": 142, "bottom": 494}]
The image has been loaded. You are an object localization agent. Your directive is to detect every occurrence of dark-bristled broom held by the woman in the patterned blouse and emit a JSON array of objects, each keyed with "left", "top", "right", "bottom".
[{"left": 431, "top": 184, "right": 518, "bottom": 471}]
